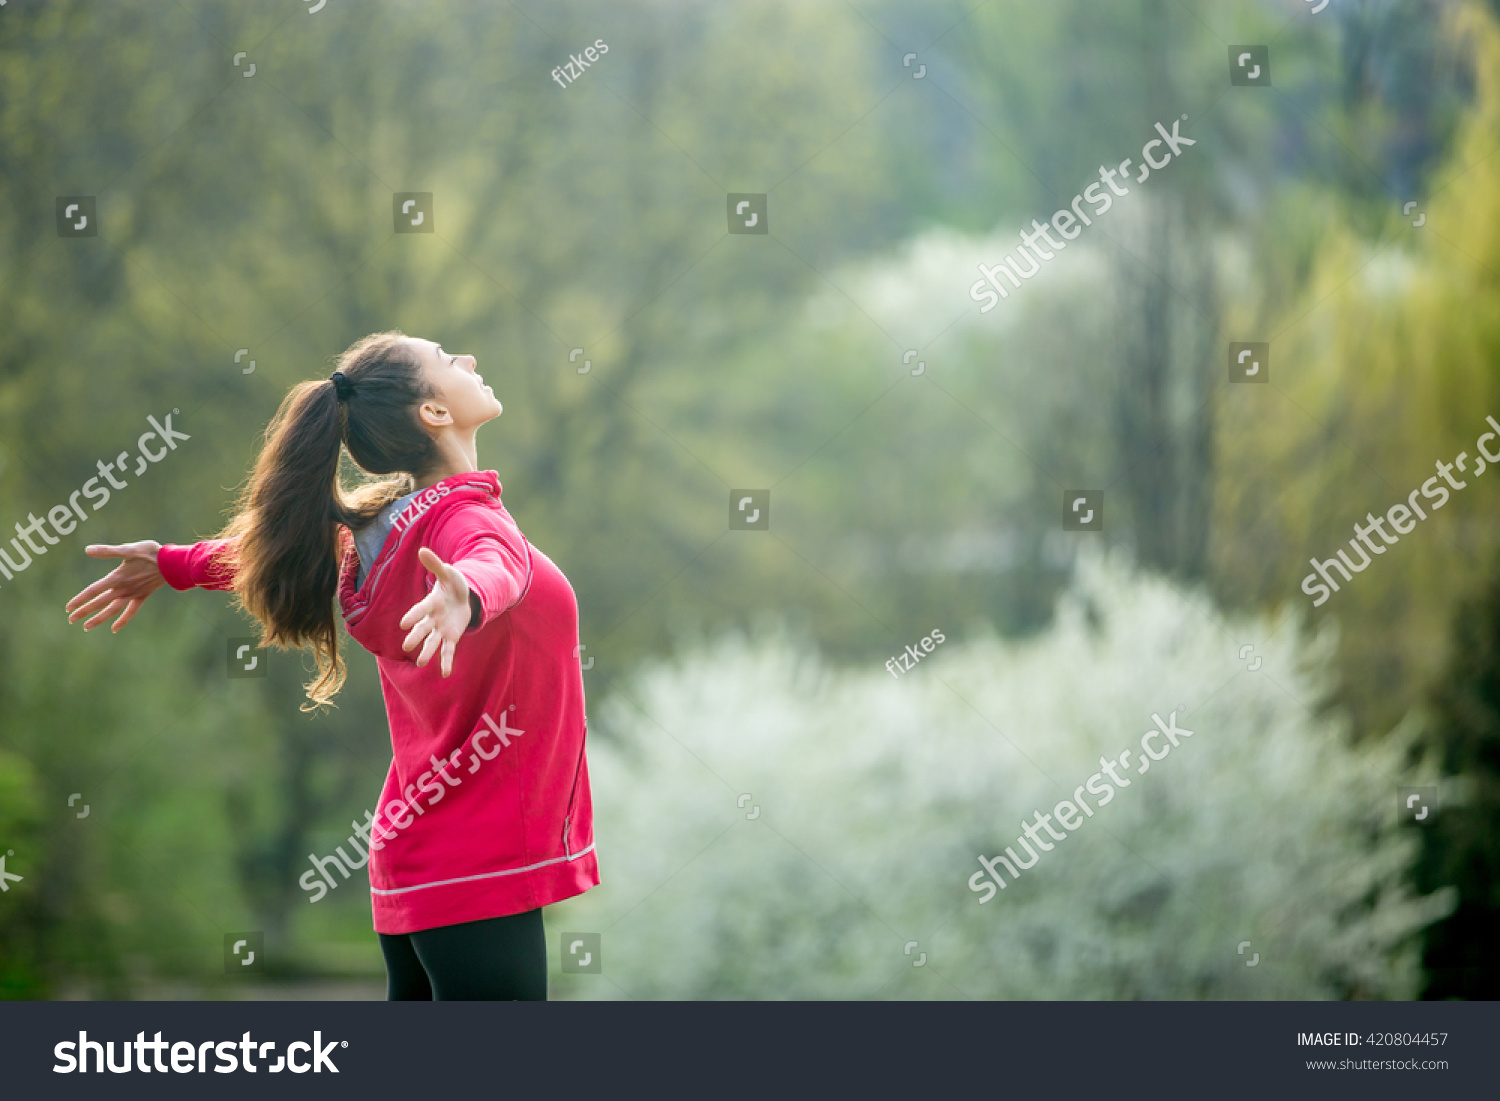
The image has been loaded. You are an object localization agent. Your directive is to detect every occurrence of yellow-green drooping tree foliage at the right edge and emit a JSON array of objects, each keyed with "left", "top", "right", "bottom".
[{"left": 1215, "top": 9, "right": 1500, "bottom": 741}]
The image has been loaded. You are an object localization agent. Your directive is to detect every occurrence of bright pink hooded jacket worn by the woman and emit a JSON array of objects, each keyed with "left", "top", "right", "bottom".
[{"left": 158, "top": 471, "right": 599, "bottom": 933}]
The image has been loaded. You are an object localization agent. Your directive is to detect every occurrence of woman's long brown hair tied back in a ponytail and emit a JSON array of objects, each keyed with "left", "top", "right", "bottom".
[{"left": 219, "top": 330, "right": 437, "bottom": 711}]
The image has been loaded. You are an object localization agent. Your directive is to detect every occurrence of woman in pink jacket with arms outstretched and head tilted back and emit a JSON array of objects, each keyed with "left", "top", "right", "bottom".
[{"left": 68, "top": 332, "right": 599, "bottom": 1001}]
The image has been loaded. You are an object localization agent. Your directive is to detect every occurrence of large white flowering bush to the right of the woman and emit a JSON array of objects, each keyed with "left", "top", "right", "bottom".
[{"left": 549, "top": 560, "right": 1451, "bottom": 999}]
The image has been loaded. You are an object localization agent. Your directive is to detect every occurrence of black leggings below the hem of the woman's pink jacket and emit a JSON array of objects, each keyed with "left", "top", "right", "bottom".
[{"left": 380, "top": 909, "right": 548, "bottom": 1002}]
